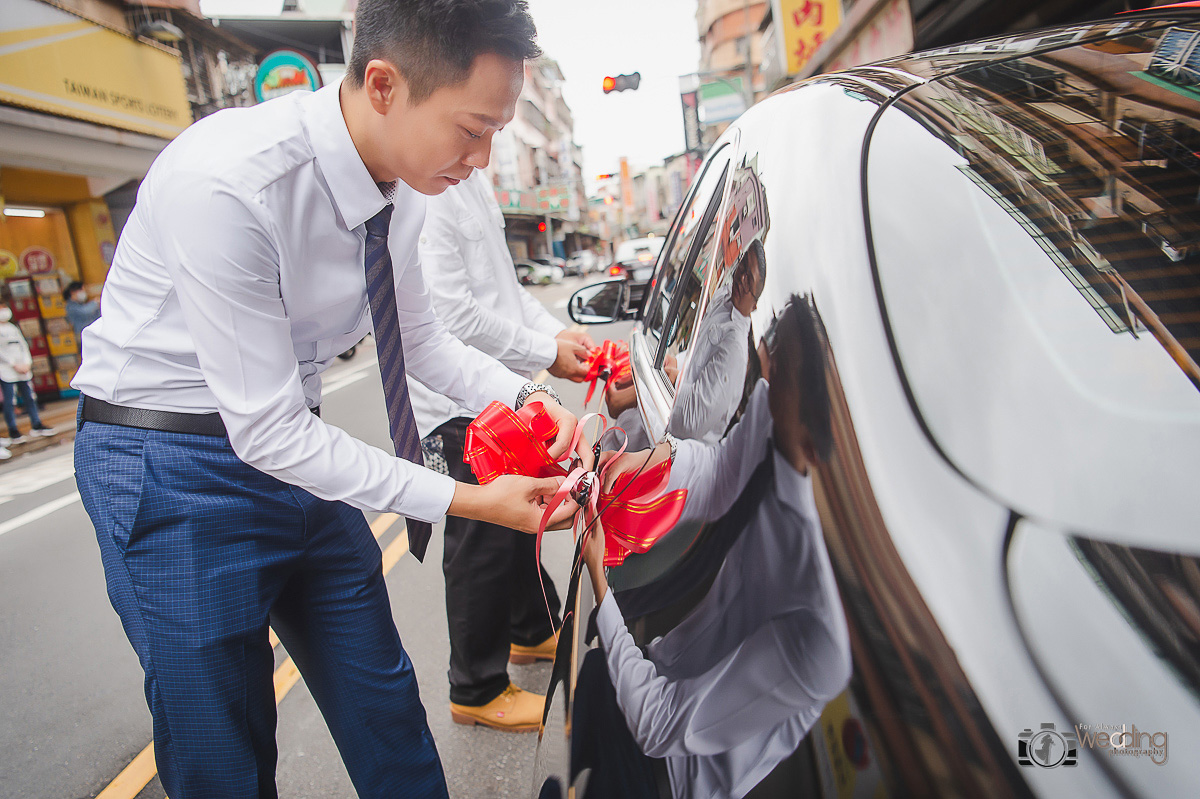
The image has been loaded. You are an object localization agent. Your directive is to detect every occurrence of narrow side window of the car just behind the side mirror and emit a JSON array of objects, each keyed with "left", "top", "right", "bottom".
[{"left": 643, "top": 145, "right": 732, "bottom": 368}]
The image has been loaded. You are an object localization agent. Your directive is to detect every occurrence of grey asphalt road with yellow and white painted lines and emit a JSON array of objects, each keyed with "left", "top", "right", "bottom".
[{"left": 0, "top": 278, "right": 629, "bottom": 799}]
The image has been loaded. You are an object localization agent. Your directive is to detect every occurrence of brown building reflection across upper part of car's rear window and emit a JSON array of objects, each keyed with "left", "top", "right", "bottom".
[{"left": 925, "top": 48, "right": 1200, "bottom": 383}]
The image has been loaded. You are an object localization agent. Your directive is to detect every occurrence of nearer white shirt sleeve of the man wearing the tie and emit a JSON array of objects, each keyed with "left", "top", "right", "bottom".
[{"left": 154, "top": 172, "right": 523, "bottom": 522}]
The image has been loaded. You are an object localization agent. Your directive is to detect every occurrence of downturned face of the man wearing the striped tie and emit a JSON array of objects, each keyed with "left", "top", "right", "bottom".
[{"left": 380, "top": 53, "right": 524, "bottom": 194}]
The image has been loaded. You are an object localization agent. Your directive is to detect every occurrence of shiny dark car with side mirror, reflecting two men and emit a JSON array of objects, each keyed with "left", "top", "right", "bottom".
[{"left": 547, "top": 10, "right": 1200, "bottom": 799}]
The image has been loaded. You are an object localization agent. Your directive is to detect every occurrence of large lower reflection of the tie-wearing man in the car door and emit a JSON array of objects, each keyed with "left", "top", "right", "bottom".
[{"left": 576, "top": 298, "right": 851, "bottom": 799}]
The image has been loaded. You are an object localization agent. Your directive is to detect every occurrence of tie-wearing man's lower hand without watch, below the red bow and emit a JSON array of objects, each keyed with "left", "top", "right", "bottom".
[{"left": 446, "top": 474, "right": 578, "bottom": 534}]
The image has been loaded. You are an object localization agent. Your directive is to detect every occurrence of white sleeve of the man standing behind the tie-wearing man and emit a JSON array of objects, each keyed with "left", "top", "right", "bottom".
[{"left": 419, "top": 202, "right": 558, "bottom": 374}]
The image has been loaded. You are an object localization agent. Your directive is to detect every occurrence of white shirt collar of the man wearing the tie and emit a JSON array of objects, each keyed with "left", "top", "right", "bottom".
[{"left": 305, "top": 83, "right": 393, "bottom": 230}]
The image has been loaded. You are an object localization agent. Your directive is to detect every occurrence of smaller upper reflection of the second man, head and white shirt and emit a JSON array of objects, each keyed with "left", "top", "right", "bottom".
[{"left": 667, "top": 239, "right": 767, "bottom": 444}]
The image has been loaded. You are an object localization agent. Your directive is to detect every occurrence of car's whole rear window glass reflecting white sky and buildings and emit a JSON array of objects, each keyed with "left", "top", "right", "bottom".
[{"left": 866, "top": 26, "right": 1200, "bottom": 549}]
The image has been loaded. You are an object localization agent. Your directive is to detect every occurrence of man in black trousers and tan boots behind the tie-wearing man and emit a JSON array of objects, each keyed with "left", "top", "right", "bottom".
[{"left": 408, "top": 172, "right": 593, "bottom": 732}]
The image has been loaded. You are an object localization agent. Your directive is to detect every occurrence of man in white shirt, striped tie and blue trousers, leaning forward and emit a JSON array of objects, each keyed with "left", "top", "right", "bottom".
[{"left": 73, "top": 0, "right": 575, "bottom": 799}]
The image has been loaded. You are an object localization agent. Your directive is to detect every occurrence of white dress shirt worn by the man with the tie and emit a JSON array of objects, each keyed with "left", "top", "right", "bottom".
[{"left": 72, "top": 85, "right": 526, "bottom": 522}]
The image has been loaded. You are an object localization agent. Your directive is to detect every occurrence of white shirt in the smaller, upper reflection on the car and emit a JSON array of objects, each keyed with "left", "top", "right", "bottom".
[{"left": 667, "top": 287, "right": 750, "bottom": 444}]
